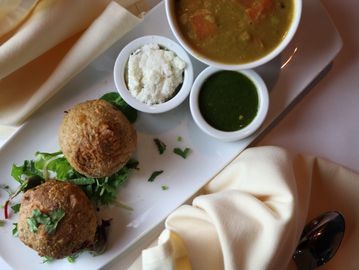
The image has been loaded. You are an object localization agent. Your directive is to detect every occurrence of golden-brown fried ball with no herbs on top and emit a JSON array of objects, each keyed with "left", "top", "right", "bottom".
[{"left": 59, "top": 100, "right": 137, "bottom": 177}]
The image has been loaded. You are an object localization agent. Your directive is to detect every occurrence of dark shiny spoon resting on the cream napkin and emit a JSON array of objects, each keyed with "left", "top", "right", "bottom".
[{"left": 293, "top": 211, "right": 345, "bottom": 270}]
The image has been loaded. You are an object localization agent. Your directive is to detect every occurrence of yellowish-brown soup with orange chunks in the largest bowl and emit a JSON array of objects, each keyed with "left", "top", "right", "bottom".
[{"left": 174, "top": 0, "right": 294, "bottom": 64}]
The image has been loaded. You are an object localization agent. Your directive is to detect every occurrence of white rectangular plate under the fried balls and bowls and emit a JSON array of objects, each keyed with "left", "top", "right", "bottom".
[{"left": 0, "top": 0, "right": 342, "bottom": 270}]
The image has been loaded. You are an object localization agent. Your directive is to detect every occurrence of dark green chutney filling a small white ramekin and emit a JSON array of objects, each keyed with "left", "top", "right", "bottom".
[{"left": 198, "top": 71, "right": 259, "bottom": 131}]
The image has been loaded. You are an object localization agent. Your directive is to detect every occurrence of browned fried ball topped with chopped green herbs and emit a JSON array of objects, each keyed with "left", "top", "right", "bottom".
[{"left": 18, "top": 180, "right": 97, "bottom": 259}]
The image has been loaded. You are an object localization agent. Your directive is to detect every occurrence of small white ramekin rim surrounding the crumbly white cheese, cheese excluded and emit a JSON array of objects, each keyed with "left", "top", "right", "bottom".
[{"left": 113, "top": 35, "right": 193, "bottom": 113}]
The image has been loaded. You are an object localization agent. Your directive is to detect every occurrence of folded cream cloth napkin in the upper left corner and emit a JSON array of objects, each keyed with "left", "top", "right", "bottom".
[{"left": 0, "top": 0, "right": 140, "bottom": 125}]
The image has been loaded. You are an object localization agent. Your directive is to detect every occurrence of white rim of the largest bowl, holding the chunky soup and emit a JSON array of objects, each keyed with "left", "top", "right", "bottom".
[{"left": 165, "top": 0, "right": 302, "bottom": 70}]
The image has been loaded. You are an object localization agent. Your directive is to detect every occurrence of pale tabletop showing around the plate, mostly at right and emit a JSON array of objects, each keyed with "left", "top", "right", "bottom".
[{"left": 0, "top": 0, "right": 359, "bottom": 270}]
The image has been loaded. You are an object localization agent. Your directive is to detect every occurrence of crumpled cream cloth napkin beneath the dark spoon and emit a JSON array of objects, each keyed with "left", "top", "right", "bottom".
[{"left": 130, "top": 147, "right": 359, "bottom": 270}]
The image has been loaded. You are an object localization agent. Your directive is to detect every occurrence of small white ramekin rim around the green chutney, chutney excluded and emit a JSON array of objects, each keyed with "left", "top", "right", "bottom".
[{"left": 190, "top": 67, "right": 269, "bottom": 142}]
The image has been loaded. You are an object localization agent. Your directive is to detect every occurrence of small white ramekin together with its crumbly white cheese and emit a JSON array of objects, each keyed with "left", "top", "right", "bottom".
[{"left": 114, "top": 35, "right": 193, "bottom": 113}]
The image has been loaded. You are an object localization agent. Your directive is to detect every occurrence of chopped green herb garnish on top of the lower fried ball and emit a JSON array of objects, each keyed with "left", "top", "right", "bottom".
[{"left": 26, "top": 209, "right": 65, "bottom": 234}]
